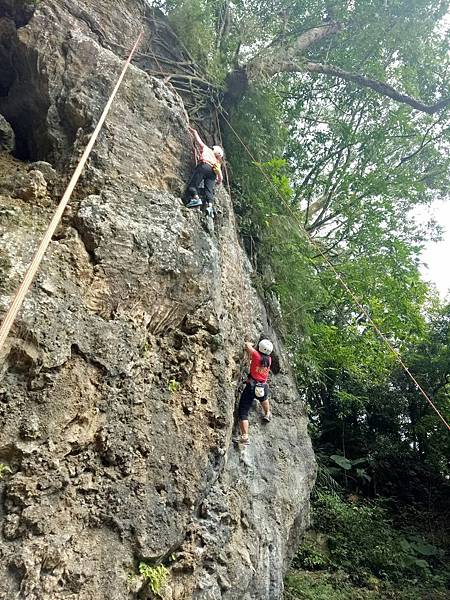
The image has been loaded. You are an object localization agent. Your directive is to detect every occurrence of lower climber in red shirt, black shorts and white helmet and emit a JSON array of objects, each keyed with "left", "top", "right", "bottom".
[{"left": 237, "top": 339, "right": 273, "bottom": 444}]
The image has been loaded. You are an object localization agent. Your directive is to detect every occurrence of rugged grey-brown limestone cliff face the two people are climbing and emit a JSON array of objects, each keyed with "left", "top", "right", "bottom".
[{"left": 0, "top": 0, "right": 315, "bottom": 600}]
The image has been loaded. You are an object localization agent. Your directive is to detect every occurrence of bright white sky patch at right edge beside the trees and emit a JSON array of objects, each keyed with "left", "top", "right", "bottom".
[{"left": 416, "top": 198, "right": 450, "bottom": 299}]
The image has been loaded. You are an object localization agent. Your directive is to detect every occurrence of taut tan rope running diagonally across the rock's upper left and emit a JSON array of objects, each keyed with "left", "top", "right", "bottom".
[{"left": 0, "top": 30, "right": 144, "bottom": 356}]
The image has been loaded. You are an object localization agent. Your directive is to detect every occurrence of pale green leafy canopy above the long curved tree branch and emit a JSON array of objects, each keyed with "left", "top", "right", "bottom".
[{"left": 163, "top": 0, "right": 448, "bottom": 104}]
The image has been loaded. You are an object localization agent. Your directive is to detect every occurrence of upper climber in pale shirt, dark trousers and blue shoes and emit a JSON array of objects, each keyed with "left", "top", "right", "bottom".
[{"left": 187, "top": 127, "right": 223, "bottom": 208}]
